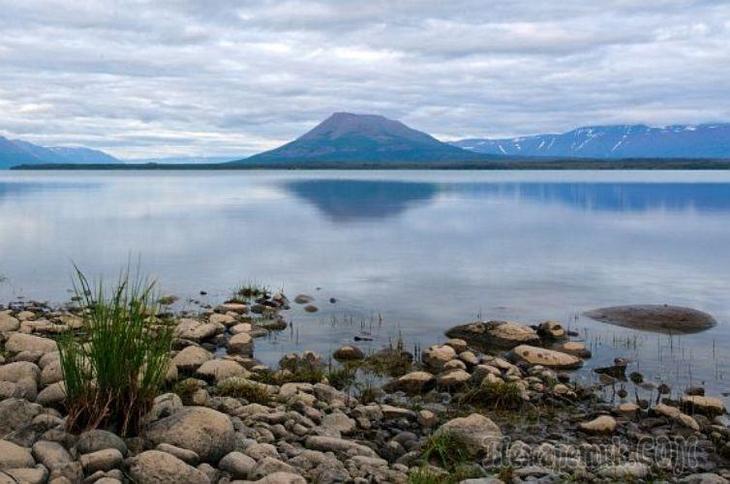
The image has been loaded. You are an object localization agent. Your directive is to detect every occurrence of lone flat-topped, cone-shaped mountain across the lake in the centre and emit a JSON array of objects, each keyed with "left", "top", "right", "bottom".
[{"left": 230, "top": 113, "right": 483, "bottom": 166}]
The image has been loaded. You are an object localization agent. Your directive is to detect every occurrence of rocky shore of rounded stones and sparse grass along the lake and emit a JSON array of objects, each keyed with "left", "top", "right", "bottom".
[{"left": 0, "top": 294, "right": 730, "bottom": 484}]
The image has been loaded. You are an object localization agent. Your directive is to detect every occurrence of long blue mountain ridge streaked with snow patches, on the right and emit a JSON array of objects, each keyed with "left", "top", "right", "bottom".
[{"left": 452, "top": 123, "right": 730, "bottom": 158}]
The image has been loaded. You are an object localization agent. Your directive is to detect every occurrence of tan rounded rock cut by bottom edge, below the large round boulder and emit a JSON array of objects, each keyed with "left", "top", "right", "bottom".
[{"left": 127, "top": 450, "right": 210, "bottom": 484}]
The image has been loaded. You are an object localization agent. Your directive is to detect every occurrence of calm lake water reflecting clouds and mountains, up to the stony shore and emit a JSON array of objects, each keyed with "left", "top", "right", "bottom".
[{"left": 0, "top": 171, "right": 730, "bottom": 393}]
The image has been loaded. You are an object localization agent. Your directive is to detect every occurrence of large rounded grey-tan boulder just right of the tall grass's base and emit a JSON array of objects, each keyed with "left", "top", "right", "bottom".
[{"left": 146, "top": 407, "right": 235, "bottom": 462}]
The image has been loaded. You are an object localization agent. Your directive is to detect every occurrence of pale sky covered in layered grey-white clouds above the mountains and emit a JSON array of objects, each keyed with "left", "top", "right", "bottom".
[{"left": 0, "top": 0, "right": 730, "bottom": 158}]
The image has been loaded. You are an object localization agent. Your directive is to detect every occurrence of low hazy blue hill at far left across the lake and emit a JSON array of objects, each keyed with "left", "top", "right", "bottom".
[{"left": 0, "top": 136, "right": 120, "bottom": 169}]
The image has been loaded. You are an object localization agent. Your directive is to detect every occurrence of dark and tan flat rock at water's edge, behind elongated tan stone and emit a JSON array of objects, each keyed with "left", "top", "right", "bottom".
[{"left": 446, "top": 321, "right": 540, "bottom": 350}]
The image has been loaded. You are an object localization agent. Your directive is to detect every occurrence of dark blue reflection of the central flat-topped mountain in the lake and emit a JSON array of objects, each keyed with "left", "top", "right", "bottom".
[{"left": 286, "top": 179, "right": 438, "bottom": 222}]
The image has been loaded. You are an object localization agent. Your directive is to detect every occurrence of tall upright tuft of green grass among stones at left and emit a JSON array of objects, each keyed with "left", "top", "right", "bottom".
[{"left": 58, "top": 268, "right": 172, "bottom": 436}]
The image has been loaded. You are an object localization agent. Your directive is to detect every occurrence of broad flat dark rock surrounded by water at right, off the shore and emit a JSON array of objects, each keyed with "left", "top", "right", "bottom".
[{"left": 585, "top": 304, "right": 717, "bottom": 334}]
